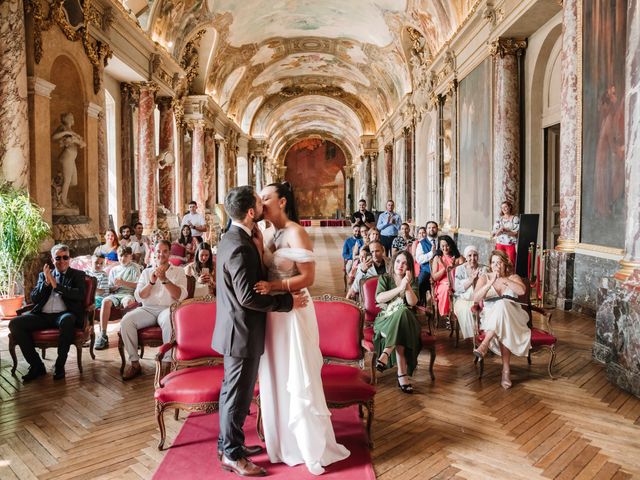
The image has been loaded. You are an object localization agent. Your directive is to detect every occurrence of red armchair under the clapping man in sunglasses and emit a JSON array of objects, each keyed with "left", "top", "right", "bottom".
[{"left": 9, "top": 275, "right": 97, "bottom": 375}]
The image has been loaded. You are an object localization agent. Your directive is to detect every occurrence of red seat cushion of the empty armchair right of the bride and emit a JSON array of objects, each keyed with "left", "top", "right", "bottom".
[{"left": 322, "top": 364, "right": 376, "bottom": 403}]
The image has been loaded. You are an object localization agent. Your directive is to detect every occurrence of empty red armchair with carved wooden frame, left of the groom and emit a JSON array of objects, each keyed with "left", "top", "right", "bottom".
[{"left": 154, "top": 296, "right": 257, "bottom": 450}]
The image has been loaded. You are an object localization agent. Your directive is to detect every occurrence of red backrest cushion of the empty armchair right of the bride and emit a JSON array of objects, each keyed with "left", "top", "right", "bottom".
[{"left": 313, "top": 301, "right": 363, "bottom": 360}]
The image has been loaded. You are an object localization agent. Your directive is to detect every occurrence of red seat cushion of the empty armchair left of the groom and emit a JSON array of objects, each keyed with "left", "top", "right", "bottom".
[{"left": 154, "top": 365, "right": 224, "bottom": 403}]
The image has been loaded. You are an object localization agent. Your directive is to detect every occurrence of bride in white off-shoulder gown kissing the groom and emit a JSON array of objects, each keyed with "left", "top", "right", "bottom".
[{"left": 255, "top": 183, "right": 350, "bottom": 475}]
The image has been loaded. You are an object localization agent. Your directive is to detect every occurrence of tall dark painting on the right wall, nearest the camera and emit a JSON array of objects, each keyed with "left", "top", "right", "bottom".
[{"left": 580, "top": 0, "right": 627, "bottom": 248}]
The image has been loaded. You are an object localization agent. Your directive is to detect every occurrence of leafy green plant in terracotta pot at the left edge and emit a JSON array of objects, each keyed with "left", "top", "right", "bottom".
[{"left": 0, "top": 184, "right": 51, "bottom": 318}]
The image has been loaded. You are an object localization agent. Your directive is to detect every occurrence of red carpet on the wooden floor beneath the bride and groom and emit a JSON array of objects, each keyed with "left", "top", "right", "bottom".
[{"left": 153, "top": 407, "right": 376, "bottom": 480}]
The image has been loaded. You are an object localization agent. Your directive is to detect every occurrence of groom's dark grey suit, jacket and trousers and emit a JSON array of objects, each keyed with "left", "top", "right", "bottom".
[{"left": 211, "top": 225, "right": 293, "bottom": 460}]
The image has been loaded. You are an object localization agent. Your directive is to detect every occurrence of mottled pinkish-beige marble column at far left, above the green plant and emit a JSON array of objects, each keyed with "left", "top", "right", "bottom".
[{"left": 0, "top": 0, "right": 29, "bottom": 188}]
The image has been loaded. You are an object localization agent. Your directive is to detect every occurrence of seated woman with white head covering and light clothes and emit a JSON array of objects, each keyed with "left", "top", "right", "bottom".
[{"left": 453, "top": 245, "right": 487, "bottom": 338}]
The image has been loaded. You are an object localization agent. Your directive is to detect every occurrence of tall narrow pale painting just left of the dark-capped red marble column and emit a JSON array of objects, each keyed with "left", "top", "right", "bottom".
[{"left": 458, "top": 58, "right": 492, "bottom": 231}]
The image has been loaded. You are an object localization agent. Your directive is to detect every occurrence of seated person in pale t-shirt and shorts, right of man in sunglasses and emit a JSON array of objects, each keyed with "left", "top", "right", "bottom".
[{"left": 94, "top": 245, "right": 140, "bottom": 350}]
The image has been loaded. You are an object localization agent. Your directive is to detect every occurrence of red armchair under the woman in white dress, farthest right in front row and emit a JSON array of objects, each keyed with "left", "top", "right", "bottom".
[{"left": 473, "top": 279, "right": 558, "bottom": 379}]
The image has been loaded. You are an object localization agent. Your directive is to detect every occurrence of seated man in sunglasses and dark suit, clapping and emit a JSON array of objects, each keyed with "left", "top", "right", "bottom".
[{"left": 9, "top": 244, "right": 85, "bottom": 383}]
